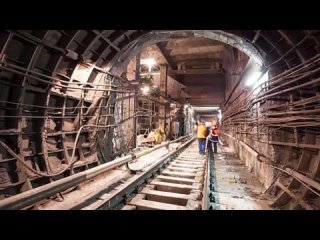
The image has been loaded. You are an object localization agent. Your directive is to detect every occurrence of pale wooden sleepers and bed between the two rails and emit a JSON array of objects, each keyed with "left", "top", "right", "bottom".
[{"left": 122, "top": 142, "right": 206, "bottom": 210}]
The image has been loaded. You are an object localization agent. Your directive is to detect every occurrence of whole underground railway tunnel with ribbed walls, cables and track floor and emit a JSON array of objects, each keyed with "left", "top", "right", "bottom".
[{"left": 0, "top": 30, "right": 320, "bottom": 210}]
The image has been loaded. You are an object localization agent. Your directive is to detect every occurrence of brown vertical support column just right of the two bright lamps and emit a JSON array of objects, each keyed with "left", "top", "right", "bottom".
[{"left": 159, "top": 65, "right": 168, "bottom": 132}]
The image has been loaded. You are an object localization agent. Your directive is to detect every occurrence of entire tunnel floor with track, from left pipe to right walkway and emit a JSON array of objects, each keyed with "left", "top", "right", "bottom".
[{"left": 0, "top": 137, "right": 270, "bottom": 210}]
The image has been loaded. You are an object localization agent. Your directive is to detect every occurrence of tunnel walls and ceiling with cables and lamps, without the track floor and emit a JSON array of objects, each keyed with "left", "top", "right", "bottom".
[{"left": 0, "top": 30, "right": 320, "bottom": 210}]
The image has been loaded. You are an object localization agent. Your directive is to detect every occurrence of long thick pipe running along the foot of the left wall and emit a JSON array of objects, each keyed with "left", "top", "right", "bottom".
[{"left": 0, "top": 136, "right": 189, "bottom": 210}]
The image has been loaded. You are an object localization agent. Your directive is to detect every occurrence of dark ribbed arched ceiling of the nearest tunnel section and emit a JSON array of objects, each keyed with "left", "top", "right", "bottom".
[{"left": 0, "top": 30, "right": 320, "bottom": 81}]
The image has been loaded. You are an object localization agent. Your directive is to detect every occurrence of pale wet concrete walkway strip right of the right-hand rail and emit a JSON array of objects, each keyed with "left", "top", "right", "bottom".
[{"left": 211, "top": 145, "right": 272, "bottom": 210}]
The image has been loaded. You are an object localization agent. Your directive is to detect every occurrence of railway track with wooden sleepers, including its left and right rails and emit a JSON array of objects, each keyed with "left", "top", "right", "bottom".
[{"left": 81, "top": 139, "right": 207, "bottom": 210}]
